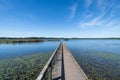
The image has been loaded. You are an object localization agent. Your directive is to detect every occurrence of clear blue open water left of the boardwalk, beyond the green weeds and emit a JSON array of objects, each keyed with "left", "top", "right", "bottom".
[{"left": 0, "top": 42, "right": 59, "bottom": 59}]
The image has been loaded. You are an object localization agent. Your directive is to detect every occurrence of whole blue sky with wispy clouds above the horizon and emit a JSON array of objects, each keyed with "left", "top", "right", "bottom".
[{"left": 0, "top": 0, "right": 120, "bottom": 38}]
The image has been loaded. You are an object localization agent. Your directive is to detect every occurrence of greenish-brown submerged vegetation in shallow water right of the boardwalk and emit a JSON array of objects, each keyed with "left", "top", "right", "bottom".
[{"left": 72, "top": 52, "right": 120, "bottom": 80}]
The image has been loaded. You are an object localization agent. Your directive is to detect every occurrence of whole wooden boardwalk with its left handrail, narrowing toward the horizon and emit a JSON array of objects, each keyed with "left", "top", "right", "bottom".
[{"left": 36, "top": 43, "right": 88, "bottom": 80}]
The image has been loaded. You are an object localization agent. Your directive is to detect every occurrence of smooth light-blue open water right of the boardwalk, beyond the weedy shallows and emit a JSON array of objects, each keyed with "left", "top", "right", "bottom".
[{"left": 65, "top": 40, "right": 120, "bottom": 54}]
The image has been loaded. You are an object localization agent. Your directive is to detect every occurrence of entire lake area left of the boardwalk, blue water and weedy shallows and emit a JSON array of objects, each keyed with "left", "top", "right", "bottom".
[{"left": 0, "top": 42, "right": 59, "bottom": 80}]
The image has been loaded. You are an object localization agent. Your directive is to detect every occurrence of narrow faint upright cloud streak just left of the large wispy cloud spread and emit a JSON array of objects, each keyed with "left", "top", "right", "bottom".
[{"left": 69, "top": 0, "right": 79, "bottom": 19}]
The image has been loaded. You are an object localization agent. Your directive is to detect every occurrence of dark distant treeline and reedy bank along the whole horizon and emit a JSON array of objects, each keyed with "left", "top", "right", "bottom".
[{"left": 0, "top": 37, "right": 120, "bottom": 43}]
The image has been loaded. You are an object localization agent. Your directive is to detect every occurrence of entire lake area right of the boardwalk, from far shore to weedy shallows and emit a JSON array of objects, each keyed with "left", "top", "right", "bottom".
[{"left": 65, "top": 40, "right": 120, "bottom": 80}]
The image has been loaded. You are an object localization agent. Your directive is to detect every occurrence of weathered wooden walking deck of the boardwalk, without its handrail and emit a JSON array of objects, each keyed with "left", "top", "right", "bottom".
[{"left": 52, "top": 43, "right": 88, "bottom": 80}]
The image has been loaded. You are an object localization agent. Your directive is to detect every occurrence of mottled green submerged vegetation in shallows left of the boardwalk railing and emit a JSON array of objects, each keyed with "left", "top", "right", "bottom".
[{"left": 0, "top": 52, "right": 51, "bottom": 80}]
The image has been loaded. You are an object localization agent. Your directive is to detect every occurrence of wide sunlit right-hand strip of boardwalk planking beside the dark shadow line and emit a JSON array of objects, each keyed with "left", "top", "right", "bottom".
[{"left": 63, "top": 44, "right": 88, "bottom": 80}]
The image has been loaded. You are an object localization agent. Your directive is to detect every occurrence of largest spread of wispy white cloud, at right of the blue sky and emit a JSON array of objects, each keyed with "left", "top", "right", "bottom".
[{"left": 79, "top": 0, "right": 120, "bottom": 28}]
